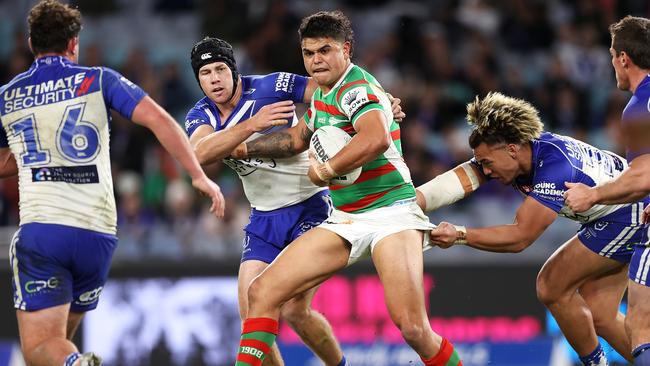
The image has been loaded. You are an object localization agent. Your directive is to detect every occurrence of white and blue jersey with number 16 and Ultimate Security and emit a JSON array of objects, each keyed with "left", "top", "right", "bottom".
[{"left": 0, "top": 56, "right": 145, "bottom": 234}]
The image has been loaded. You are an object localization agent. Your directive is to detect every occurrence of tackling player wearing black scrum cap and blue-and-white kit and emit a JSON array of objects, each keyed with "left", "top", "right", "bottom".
[{"left": 185, "top": 37, "right": 403, "bottom": 365}]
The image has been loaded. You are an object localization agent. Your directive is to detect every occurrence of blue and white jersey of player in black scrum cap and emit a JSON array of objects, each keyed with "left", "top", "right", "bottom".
[{"left": 185, "top": 72, "right": 325, "bottom": 211}]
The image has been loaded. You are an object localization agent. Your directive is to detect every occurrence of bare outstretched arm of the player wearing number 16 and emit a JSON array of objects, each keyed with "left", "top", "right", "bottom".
[{"left": 131, "top": 96, "right": 225, "bottom": 217}]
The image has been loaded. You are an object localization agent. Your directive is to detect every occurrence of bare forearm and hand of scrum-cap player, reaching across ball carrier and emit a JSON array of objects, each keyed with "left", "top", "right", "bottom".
[{"left": 190, "top": 100, "right": 295, "bottom": 165}]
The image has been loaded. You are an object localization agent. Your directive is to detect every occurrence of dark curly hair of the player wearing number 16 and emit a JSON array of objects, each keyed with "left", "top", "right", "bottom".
[{"left": 27, "top": 0, "right": 81, "bottom": 55}]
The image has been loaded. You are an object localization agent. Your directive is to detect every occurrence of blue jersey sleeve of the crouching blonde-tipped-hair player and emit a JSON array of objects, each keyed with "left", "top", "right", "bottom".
[{"left": 528, "top": 156, "right": 572, "bottom": 213}]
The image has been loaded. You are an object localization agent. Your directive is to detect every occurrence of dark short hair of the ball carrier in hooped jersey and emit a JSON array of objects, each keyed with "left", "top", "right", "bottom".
[{"left": 298, "top": 10, "right": 354, "bottom": 57}]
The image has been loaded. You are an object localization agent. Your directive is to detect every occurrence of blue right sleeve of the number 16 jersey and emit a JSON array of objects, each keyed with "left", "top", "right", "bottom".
[{"left": 102, "top": 67, "right": 147, "bottom": 119}]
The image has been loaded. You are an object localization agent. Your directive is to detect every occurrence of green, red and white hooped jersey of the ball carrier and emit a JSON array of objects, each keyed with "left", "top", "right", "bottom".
[{"left": 304, "top": 63, "right": 415, "bottom": 213}]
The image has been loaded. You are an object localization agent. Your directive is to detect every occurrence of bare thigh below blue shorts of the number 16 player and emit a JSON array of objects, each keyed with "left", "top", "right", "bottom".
[{"left": 16, "top": 304, "right": 70, "bottom": 350}]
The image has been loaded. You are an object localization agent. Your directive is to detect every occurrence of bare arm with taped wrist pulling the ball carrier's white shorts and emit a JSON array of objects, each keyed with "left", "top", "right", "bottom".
[{"left": 430, "top": 197, "right": 557, "bottom": 253}]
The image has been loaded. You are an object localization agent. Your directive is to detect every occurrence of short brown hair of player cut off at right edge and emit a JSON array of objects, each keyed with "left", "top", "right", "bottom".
[{"left": 609, "top": 15, "right": 650, "bottom": 69}]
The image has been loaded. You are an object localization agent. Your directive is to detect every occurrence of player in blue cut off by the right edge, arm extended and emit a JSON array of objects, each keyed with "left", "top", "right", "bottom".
[{"left": 566, "top": 16, "right": 650, "bottom": 366}]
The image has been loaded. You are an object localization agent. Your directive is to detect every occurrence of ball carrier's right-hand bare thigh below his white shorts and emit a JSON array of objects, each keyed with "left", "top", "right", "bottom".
[{"left": 372, "top": 229, "right": 426, "bottom": 318}]
